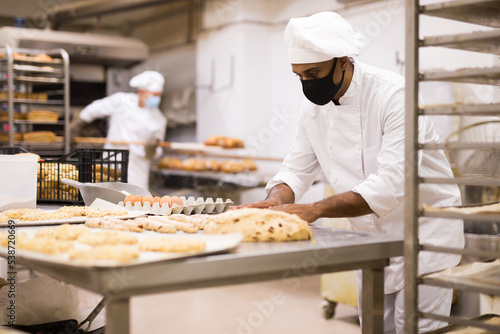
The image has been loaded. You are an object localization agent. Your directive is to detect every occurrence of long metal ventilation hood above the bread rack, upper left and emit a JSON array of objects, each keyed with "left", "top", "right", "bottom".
[{"left": 0, "top": 27, "right": 148, "bottom": 67}]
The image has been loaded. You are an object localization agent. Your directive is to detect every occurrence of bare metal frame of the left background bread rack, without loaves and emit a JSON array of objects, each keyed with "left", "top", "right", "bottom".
[{"left": 0, "top": 44, "right": 71, "bottom": 154}]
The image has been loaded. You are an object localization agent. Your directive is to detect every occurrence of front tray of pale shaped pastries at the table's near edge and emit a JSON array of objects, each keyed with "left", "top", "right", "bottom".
[{"left": 0, "top": 224, "right": 242, "bottom": 267}]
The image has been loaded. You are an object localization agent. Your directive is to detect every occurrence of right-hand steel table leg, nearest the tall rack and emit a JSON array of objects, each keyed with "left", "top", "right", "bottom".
[{"left": 361, "top": 268, "right": 384, "bottom": 334}]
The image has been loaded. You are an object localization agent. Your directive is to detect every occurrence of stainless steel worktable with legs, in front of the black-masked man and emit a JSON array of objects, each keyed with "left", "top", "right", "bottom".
[{"left": 7, "top": 227, "right": 403, "bottom": 334}]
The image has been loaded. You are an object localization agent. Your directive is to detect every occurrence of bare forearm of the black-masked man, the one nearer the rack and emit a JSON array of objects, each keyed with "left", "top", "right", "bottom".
[{"left": 312, "top": 191, "right": 373, "bottom": 218}]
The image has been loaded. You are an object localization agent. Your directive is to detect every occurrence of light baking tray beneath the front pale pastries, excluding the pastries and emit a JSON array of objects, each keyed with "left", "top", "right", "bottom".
[{"left": 0, "top": 227, "right": 243, "bottom": 268}]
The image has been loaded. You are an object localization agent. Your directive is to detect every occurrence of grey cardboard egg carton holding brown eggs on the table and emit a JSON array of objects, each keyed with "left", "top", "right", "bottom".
[{"left": 118, "top": 196, "right": 234, "bottom": 216}]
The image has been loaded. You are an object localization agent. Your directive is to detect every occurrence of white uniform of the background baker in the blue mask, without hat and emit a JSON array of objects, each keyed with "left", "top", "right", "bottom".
[{"left": 80, "top": 93, "right": 167, "bottom": 189}]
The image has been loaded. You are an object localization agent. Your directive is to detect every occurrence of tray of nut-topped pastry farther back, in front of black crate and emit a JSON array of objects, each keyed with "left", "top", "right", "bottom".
[{"left": 0, "top": 206, "right": 145, "bottom": 227}]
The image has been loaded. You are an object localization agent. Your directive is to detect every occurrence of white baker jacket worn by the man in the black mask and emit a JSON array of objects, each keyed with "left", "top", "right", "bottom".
[{"left": 266, "top": 62, "right": 464, "bottom": 293}]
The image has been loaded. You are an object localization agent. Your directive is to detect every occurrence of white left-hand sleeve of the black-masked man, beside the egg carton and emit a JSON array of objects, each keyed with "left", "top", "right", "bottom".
[{"left": 266, "top": 105, "right": 321, "bottom": 201}]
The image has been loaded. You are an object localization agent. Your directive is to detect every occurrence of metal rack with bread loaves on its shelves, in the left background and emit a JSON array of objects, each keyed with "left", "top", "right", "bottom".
[{"left": 0, "top": 44, "right": 71, "bottom": 156}]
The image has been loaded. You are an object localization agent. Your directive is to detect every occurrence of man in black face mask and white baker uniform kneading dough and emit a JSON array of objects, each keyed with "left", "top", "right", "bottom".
[{"left": 242, "top": 12, "right": 464, "bottom": 333}]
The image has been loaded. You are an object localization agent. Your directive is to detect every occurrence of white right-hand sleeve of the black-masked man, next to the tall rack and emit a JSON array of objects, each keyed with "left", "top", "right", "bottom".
[{"left": 352, "top": 88, "right": 406, "bottom": 217}]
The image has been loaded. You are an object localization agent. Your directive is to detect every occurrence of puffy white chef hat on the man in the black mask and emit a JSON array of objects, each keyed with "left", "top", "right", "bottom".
[{"left": 285, "top": 12, "right": 365, "bottom": 64}]
